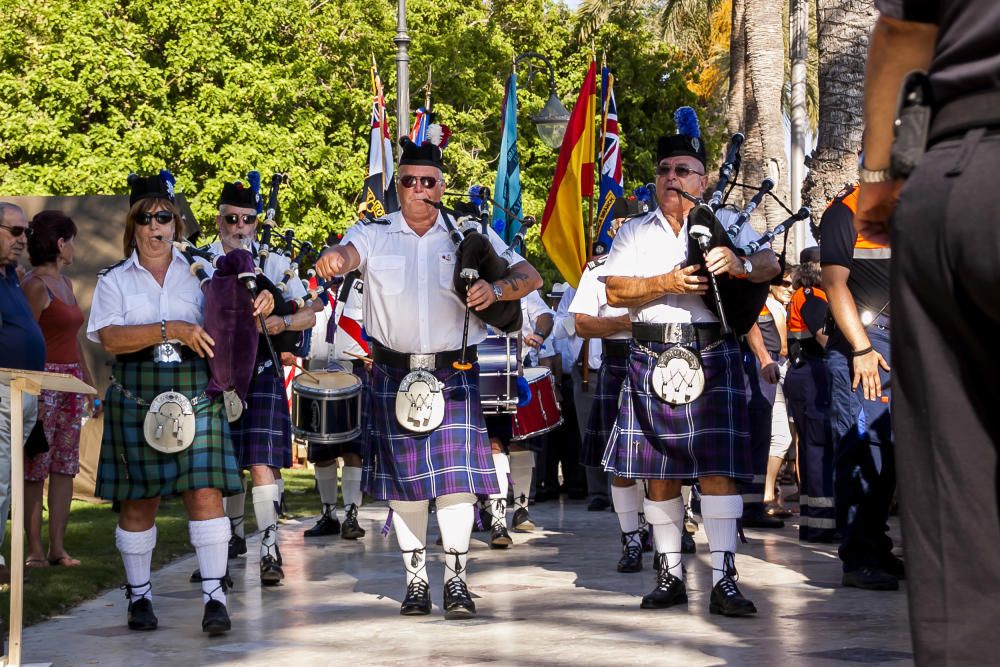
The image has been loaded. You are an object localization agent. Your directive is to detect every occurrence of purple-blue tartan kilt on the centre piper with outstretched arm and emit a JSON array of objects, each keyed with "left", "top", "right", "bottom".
[{"left": 364, "top": 364, "right": 500, "bottom": 500}]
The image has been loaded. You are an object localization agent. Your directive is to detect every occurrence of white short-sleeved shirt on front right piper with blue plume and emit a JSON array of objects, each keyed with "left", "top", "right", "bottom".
[{"left": 604, "top": 208, "right": 768, "bottom": 324}]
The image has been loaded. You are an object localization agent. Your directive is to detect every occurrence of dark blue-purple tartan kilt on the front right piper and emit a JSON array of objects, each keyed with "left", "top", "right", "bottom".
[{"left": 603, "top": 341, "right": 753, "bottom": 481}]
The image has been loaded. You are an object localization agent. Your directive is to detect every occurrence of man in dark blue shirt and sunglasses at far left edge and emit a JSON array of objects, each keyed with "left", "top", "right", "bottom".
[{"left": 0, "top": 202, "right": 45, "bottom": 580}]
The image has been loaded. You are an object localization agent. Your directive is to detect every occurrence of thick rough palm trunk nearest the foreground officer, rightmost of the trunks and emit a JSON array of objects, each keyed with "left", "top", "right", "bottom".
[{"left": 802, "top": 0, "right": 876, "bottom": 220}]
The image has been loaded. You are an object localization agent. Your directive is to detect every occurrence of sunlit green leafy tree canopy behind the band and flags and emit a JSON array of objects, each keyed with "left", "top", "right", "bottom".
[{"left": 0, "top": 0, "right": 722, "bottom": 279}]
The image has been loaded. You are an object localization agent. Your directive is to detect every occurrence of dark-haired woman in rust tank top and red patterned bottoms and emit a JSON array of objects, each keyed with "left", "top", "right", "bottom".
[{"left": 22, "top": 211, "right": 94, "bottom": 567}]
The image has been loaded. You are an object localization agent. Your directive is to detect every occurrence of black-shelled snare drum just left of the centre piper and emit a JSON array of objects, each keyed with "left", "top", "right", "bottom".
[{"left": 292, "top": 371, "right": 361, "bottom": 443}]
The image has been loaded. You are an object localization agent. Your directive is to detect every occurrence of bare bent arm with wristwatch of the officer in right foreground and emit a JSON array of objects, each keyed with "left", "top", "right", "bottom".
[{"left": 864, "top": 16, "right": 937, "bottom": 169}]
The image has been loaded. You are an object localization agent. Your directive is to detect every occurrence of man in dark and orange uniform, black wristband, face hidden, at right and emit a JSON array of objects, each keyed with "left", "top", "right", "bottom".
[{"left": 820, "top": 186, "right": 903, "bottom": 590}]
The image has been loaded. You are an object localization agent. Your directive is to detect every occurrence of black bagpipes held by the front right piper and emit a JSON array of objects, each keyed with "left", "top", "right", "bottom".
[{"left": 680, "top": 132, "right": 810, "bottom": 335}]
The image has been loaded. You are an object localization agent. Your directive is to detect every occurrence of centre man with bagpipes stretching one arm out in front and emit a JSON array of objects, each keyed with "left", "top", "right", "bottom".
[{"left": 316, "top": 137, "right": 542, "bottom": 619}]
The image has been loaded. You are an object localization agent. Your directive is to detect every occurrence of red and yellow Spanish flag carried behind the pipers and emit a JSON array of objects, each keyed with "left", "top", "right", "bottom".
[{"left": 542, "top": 60, "right": 597, "bottom": 287}]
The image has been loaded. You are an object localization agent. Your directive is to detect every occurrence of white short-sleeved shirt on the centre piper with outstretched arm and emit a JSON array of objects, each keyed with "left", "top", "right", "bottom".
[{"left": 341, "top": 211, "right": 524, "bottom": 354}]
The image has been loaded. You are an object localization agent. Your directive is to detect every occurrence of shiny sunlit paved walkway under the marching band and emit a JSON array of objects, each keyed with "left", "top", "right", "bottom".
[{"left": 24, "top": 502, "right": 912, "bottom": 667}]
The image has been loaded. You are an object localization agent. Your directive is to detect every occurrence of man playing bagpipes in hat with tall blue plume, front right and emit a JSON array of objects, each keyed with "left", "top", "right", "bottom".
[{"left": 602, "top": 108, "right": 779, "bottom": 616}]
